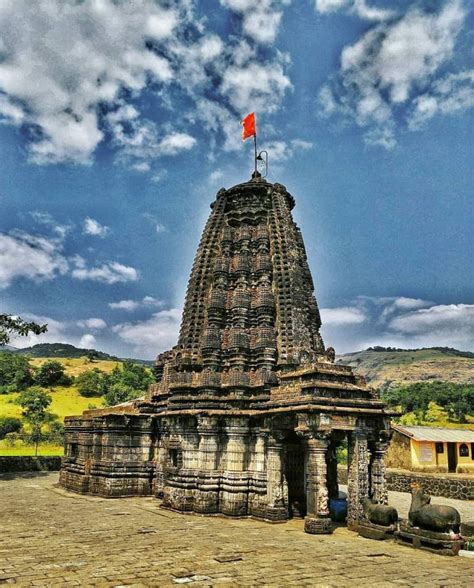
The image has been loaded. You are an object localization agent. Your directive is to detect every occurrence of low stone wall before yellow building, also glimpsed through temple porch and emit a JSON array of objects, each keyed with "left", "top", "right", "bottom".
[{"left": 337, "top": 466, "right": 474, "bottom": 500}]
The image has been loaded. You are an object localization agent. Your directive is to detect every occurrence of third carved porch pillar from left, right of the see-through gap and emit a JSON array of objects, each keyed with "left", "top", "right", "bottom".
[{"left": 347, "top": 431, "right": 369, "bottom": 531}]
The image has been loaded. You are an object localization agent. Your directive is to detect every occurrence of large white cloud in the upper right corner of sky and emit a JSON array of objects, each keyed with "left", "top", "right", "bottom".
[{"left": 319, "top": 0, "right": 466, "bottom": 149}]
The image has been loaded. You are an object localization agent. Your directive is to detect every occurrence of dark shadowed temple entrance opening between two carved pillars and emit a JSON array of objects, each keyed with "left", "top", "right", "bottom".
[{"left": 285, "top": 431, "right": 306, "bottom": 519}]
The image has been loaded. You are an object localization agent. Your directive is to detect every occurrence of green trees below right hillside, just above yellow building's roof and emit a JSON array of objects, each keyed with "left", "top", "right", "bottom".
[{"left": 382, "top": 382, "right": 474, "bottom": 424}]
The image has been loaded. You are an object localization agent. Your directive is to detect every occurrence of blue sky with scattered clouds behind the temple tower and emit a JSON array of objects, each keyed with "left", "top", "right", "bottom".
[{"left": 0, "top": 0, "right": 474, "bottom": 358}]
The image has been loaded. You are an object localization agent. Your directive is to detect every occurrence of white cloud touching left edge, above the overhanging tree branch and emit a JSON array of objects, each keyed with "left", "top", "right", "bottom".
[{"left": 0, "top": 231, "right": 68, "bottom": 289}]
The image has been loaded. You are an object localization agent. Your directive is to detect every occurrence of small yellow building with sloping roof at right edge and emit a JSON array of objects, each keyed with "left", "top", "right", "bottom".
[{"left": 387, "top": 424, "right": 474, "bottom": 474}]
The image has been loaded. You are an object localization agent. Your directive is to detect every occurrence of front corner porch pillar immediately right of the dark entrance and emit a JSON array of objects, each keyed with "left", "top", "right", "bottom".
[{"left": 304, "top": 432, "right": 332, "bottom": 535}]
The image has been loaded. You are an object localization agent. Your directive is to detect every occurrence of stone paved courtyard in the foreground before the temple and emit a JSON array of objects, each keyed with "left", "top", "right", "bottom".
[{"left": 0, "top": 473, "right": 474, "bottom": 588}]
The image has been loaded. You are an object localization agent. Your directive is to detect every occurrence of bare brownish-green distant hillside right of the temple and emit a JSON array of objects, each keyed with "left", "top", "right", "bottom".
[{"left": 336, "top": 347, "right": 474, "bottom": 388}]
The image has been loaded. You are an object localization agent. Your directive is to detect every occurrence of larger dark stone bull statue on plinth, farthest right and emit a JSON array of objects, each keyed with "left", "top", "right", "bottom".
[{"left": 396, "top": 484, "right": 464, "bottom": 555}]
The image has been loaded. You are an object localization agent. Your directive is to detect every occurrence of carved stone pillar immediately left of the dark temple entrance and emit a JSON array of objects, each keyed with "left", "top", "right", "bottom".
[{"left": 265, "top": 431, "right": 288, "bottom": 521}]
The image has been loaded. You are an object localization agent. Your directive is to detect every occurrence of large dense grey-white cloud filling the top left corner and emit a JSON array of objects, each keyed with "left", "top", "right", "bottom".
[{"left": 0, "top": 0, "right": 178, "bottom": 163}]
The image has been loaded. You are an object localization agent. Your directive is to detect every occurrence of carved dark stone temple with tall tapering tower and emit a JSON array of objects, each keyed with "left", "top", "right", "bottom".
[{"left": 60, "top": 172, "right": 390, "bottom": 533}]
